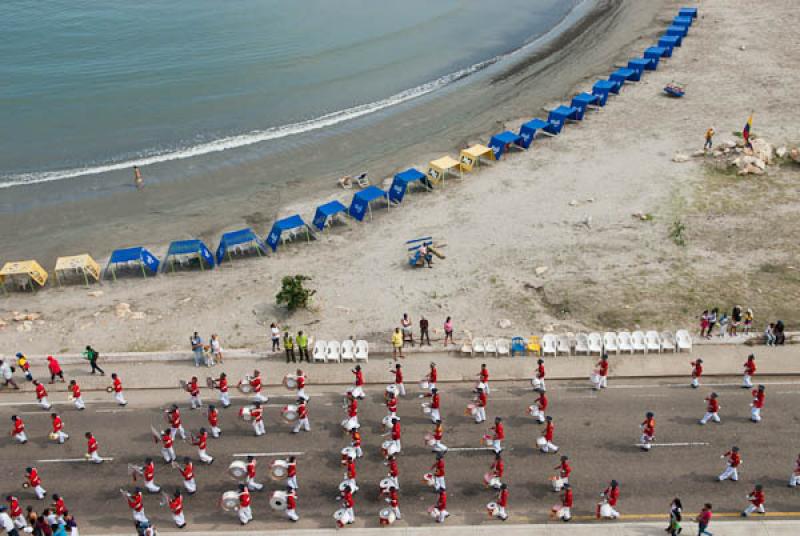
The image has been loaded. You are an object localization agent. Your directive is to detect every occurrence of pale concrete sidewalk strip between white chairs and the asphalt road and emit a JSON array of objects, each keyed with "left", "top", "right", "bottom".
[{"left": 3, "top": 345, "right": 800, "bottom": 392}]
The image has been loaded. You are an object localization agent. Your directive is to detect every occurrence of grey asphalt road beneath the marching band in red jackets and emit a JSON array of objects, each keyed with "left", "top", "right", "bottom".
[{"left": 0, "top": 377, "right": 800, "bottom": 534}]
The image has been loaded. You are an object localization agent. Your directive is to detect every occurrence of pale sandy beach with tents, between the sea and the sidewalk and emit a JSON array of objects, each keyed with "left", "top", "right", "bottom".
[{"left": 0, "top": 0, "right": 800, "bottom": 354}]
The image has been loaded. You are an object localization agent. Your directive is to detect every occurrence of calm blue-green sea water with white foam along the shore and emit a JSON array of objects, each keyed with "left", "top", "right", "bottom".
[{"left": 0, "top": 0, "right": 580, "bottom": 188}]
